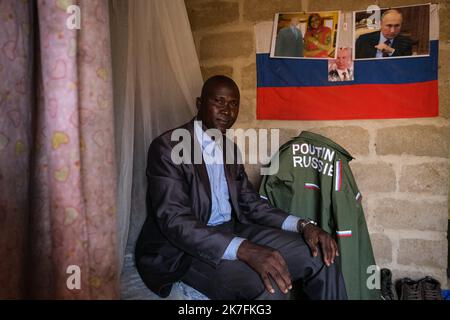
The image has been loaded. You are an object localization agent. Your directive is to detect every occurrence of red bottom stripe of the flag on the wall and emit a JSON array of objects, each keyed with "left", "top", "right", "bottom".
[{"left": 257, "top": 80, "right": 439, "bottom": 120}]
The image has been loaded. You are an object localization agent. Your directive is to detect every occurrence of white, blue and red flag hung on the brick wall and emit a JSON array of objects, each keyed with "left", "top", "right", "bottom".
[{"left": 255, "top": 6, "right": 439, "bottom": 120}]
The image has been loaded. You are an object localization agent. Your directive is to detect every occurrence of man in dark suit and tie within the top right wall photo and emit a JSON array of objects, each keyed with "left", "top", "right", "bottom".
[{"left": 355, "top": 9, "right": 412, "bottom": 59}]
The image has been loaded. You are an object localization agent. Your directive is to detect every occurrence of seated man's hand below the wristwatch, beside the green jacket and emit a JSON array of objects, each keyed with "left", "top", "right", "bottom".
[{"left": 303, "top": 224, "right": 339, "bottom": 267}]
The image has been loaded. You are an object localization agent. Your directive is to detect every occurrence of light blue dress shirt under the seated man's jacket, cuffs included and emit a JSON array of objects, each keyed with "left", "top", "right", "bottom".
[{"left": 194, "top": 121, "right": 300, "bottom": 260}]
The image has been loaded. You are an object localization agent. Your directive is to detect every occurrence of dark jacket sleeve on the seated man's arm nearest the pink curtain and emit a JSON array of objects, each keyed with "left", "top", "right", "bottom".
[{"left": 147, "top": 138, "right": 234, "bottom": 265}]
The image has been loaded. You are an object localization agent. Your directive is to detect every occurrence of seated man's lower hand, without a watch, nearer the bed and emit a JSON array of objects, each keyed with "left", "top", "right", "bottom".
[{"left": 237, "top": 240, "right": 292, "bottom": 293}]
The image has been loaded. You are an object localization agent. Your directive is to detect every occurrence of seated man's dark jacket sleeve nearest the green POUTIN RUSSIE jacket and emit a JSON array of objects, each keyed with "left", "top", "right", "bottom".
[{"left": 236, "top": 165, "right": 288, "bottom": 228}]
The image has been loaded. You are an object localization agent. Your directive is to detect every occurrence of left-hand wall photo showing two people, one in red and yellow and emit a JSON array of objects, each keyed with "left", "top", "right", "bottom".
[{"left": 270, "top": 11, "right": 339, "bottom": 59}]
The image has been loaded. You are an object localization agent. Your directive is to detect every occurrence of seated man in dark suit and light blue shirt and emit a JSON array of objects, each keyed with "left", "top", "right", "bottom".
[{"left": 135, "top": 76, "right": 347, "bottom": 300}]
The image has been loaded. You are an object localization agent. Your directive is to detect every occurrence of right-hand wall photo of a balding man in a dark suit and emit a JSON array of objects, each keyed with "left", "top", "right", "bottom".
[{"left": 353, "top": 4, "right": 430, "bottom": 60}]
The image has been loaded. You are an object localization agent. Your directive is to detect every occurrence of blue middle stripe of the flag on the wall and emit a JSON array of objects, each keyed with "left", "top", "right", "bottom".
[{"left": 256, "top": 40, "right": 439, "bottom": 87}]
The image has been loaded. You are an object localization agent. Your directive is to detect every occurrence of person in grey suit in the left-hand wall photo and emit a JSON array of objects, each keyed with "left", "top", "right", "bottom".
[{"left": 275, "top": 17, "right": 303, "bottom": 57}]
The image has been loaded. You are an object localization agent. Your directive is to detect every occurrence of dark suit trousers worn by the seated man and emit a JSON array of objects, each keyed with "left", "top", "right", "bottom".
[{"left": 182, "top": 220, "right": 347, "bottom": 300}]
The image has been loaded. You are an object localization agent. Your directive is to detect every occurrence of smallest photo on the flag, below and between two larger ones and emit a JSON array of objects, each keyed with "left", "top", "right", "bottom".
[{"left": 328, "top": 47, "right": 354, "bottom": 82}]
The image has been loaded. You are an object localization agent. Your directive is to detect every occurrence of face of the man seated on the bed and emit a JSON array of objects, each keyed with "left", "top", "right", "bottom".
[{"left": 197, "top": 82, "right": 240, "bottom": 134}]
